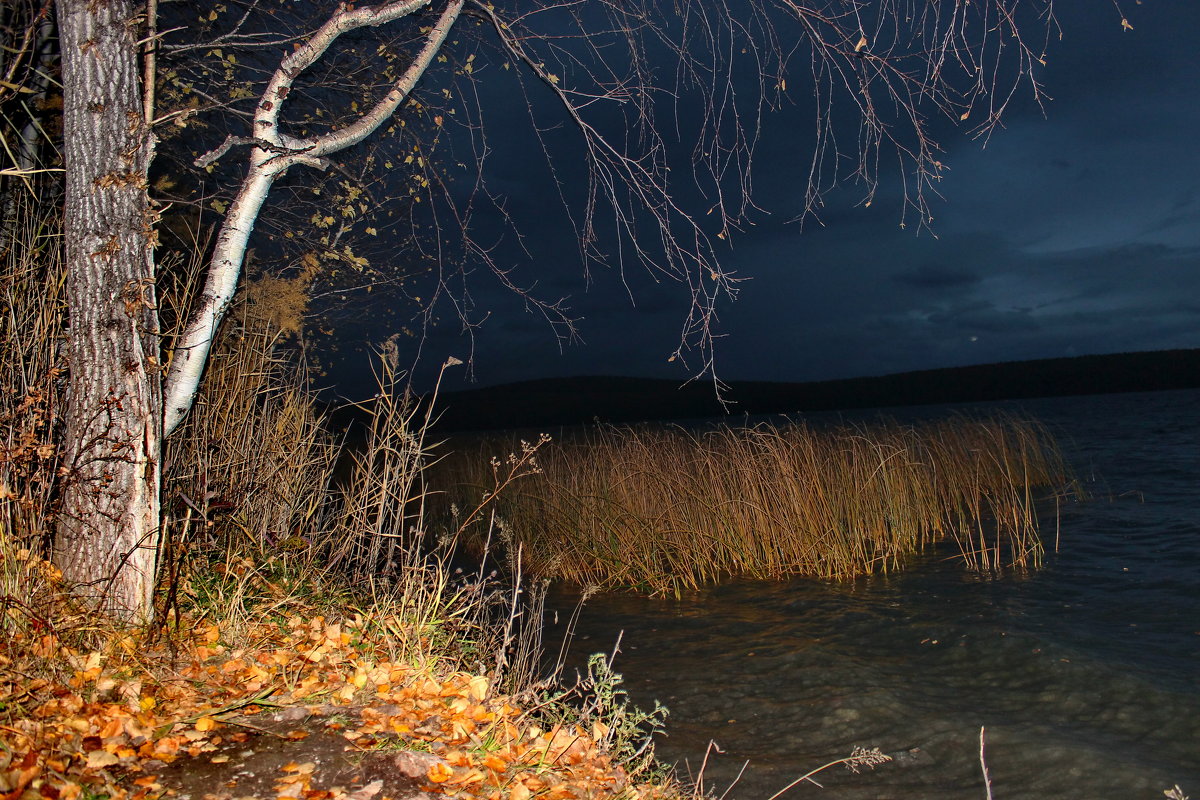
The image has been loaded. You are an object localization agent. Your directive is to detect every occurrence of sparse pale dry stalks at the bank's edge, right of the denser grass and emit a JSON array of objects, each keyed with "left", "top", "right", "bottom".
[{"left": 320, "top": 359, "right": 542, "bottom": 688}]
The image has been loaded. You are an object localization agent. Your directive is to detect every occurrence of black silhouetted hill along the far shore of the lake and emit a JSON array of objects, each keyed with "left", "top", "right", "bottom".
[{"left": 427, "top": 349, "right": 1200, "bottom": 432}]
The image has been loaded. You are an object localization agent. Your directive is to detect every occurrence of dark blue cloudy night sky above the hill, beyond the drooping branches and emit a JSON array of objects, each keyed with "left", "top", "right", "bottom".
[{"left": 335, "top": 0, "right": 1200, "bottom": 398}]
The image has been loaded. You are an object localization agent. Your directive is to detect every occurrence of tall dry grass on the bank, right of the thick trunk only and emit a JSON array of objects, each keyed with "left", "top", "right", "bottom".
[{"left": 160, "top": 307, "right": 537, "bottom": 684}]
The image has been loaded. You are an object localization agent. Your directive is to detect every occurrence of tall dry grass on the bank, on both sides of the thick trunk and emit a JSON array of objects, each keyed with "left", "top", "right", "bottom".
[{"left": 0, "top": 182, "right": 540, "bottom": 684}]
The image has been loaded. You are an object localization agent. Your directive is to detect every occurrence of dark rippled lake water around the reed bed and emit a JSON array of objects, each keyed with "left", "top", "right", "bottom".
[{"left": 547, "top": 391, "right": 1200, "bottom": 800}]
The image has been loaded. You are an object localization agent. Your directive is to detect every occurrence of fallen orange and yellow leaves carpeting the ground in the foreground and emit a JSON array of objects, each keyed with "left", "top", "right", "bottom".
[{"left": 0, "top": 615, "right": 666, "bottom": 800}]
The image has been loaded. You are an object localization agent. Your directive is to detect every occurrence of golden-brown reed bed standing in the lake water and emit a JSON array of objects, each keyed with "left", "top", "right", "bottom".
[{"left": 442, "top": 415, "right": 1074, "bottom": 593}]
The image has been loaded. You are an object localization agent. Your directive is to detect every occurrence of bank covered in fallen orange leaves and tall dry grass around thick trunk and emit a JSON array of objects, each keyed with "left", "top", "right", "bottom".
[{"left": 0, "top": 188, "right": 662, "bottom": 800}]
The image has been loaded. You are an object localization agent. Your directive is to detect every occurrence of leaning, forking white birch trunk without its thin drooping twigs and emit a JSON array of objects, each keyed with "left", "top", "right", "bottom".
[{"left": 163, "top": 0, "right": 466, "bottom": 435}]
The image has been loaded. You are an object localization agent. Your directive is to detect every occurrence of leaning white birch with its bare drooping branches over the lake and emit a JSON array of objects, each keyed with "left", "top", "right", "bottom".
[{"left": 157, "top": 0, "right": 1054, "bottom": 412}]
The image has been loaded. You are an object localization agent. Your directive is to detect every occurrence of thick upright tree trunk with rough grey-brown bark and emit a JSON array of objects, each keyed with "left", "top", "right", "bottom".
[{"left": 54, "top": 0, "right": 162, "bottom": 619}]
